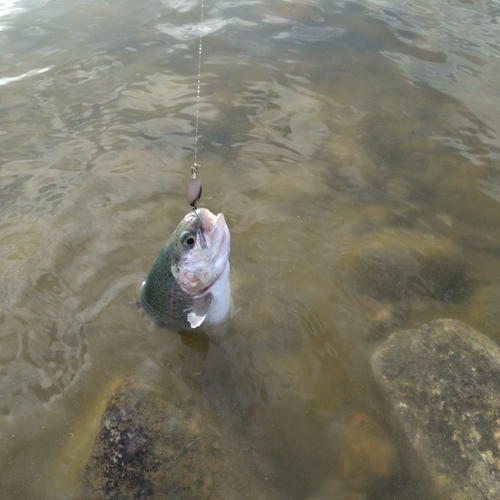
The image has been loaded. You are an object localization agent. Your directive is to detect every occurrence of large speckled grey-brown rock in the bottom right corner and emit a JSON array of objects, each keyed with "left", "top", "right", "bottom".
[{"left": 371, "top": 319, "right": 500, "bottom": 500}]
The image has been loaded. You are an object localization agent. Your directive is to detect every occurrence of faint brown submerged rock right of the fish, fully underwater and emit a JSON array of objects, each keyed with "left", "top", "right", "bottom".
[{"left": 342, "top": 228, "right": 468, "bottom": 301}]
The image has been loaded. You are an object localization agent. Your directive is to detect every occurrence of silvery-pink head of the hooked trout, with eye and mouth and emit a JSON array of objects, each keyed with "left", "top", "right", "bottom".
[{"left": 171, "top": 208, "right": 230, "bottom": 298}]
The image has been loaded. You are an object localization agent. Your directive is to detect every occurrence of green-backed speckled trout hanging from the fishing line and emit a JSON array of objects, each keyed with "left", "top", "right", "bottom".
[{"left": 140, "top": 208, "right": 231, "bottom": 333}]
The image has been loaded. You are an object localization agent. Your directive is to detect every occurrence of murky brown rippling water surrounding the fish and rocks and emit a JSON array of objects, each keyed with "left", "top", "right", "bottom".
[{"left": 0, "top": 0, "right": 500, "bottom": 500}]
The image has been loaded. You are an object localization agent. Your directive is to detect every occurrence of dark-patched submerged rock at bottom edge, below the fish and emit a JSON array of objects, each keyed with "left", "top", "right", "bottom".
[{"left": 82, "top": 381, "right": 279, "bottom": 500}]
